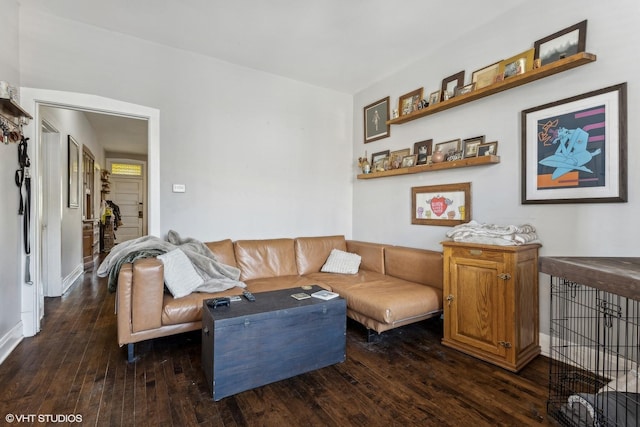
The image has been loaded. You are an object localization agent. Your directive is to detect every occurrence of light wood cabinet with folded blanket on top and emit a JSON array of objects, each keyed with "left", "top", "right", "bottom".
[{"left": 442, "top": 242, "right": 540, "bottom": 372}]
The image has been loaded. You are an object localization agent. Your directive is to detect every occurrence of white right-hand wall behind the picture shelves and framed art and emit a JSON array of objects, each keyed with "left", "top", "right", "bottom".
[{"left": 353, "top": 0, "right": 640, "bottom": 342}]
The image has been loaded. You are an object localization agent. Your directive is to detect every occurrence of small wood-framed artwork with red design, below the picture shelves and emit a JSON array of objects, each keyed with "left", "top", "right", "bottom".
[{"left": 411, "top": 182, "right": 471, "bottom": 226}]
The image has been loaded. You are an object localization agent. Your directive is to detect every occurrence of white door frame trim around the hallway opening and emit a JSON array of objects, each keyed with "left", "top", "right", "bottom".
[{"left": 21, "top": 88, "right": 160, "bottom": 336}]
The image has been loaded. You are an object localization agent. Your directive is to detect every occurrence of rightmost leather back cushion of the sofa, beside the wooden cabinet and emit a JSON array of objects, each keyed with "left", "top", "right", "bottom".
[{"left": 384, "top": 246, "right": 443, "bottom": 289}]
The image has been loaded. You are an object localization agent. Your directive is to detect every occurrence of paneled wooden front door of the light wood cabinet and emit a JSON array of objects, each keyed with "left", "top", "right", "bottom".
[{"left": 445, "top": 258, "right": 506, "bottom": 357}]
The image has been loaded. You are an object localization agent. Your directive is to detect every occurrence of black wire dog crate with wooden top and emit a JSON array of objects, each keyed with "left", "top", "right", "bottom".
[{"left": 540, "top": 257, "right": 640, "bottom": 426}]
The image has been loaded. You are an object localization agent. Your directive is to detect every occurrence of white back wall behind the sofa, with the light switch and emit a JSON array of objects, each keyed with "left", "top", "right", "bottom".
[{"left": 20, "top": 8, "right": 352, "bottom": 240}]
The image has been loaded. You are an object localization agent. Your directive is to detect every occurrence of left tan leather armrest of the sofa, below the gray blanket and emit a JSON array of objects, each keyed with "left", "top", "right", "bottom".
[{"left": 117, "top": 258, "right": 164, "bottom": 345}]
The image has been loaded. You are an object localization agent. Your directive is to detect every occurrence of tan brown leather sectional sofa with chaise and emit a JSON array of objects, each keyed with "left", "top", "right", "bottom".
[{"left": 116, "top": 236, "right": 443, "bottom": 359}]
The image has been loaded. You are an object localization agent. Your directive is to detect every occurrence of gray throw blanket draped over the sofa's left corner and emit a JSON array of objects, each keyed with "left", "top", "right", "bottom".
[{"left": 98, "top": 230, "right": 246, "bottom": 292}]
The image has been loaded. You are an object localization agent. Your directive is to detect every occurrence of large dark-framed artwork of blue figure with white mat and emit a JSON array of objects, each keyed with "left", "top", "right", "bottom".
[{"left": 521, "top": 83, "right": 627, "bottom": 204}]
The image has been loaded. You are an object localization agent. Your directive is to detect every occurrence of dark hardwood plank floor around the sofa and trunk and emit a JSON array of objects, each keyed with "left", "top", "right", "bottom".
[{"left": 0, "top": 266, "right": 556, "bottom": 427}]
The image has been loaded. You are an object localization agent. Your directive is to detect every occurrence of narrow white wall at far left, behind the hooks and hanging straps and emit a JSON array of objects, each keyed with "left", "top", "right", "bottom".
[{"left": 0, "top": 0, "right": 24, "bottom": 362}]
